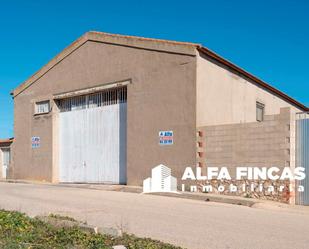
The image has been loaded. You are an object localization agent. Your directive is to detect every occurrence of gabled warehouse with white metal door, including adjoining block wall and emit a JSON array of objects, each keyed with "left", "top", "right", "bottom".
[{"left": 9, "top": 32, "right": 308, "bottom": 204}]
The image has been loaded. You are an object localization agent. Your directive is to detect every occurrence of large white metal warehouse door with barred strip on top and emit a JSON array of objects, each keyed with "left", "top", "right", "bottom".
[{"left": 58, "top": 88, "right": 127, "bottom": 184}]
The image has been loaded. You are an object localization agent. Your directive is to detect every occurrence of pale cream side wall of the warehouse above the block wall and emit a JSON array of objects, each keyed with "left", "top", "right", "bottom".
[{"left": 196, "top": 51, "right": 300, "bottom": 127}]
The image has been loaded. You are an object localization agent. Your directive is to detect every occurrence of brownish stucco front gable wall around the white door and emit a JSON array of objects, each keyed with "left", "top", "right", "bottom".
[{"left": 12, "top": 41, "right": 196, "bottom": 185}]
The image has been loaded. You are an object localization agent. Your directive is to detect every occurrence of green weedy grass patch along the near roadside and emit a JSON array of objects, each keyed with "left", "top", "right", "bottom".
[{"left": 0, "top": 210, "right": 181, "bottom": 249}]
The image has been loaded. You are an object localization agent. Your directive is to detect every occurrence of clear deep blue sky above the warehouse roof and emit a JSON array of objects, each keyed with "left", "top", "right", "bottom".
[{"left": 0, "top": 0, "right": 309, "bottom": 138}]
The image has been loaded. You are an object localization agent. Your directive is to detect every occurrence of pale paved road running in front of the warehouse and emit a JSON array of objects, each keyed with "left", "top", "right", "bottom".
[{"left": 0, "top": 183, "right": 309, "bottom": 249}]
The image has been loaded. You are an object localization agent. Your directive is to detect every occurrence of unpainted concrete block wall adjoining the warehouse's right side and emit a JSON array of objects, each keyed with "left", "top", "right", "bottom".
[{"left": 197, "top": 107, "right": 295, "bottom": 202}]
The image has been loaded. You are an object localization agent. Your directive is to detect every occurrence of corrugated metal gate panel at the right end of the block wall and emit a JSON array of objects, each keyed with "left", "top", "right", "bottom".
[{"left": 296, "top": 118, "right": 309, "bottom": 205}]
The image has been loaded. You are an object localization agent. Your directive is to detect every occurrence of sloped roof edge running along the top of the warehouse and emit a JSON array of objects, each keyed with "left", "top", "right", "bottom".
[{"left": 11, "top": 31, "right": 309, "bottom": 111}]
